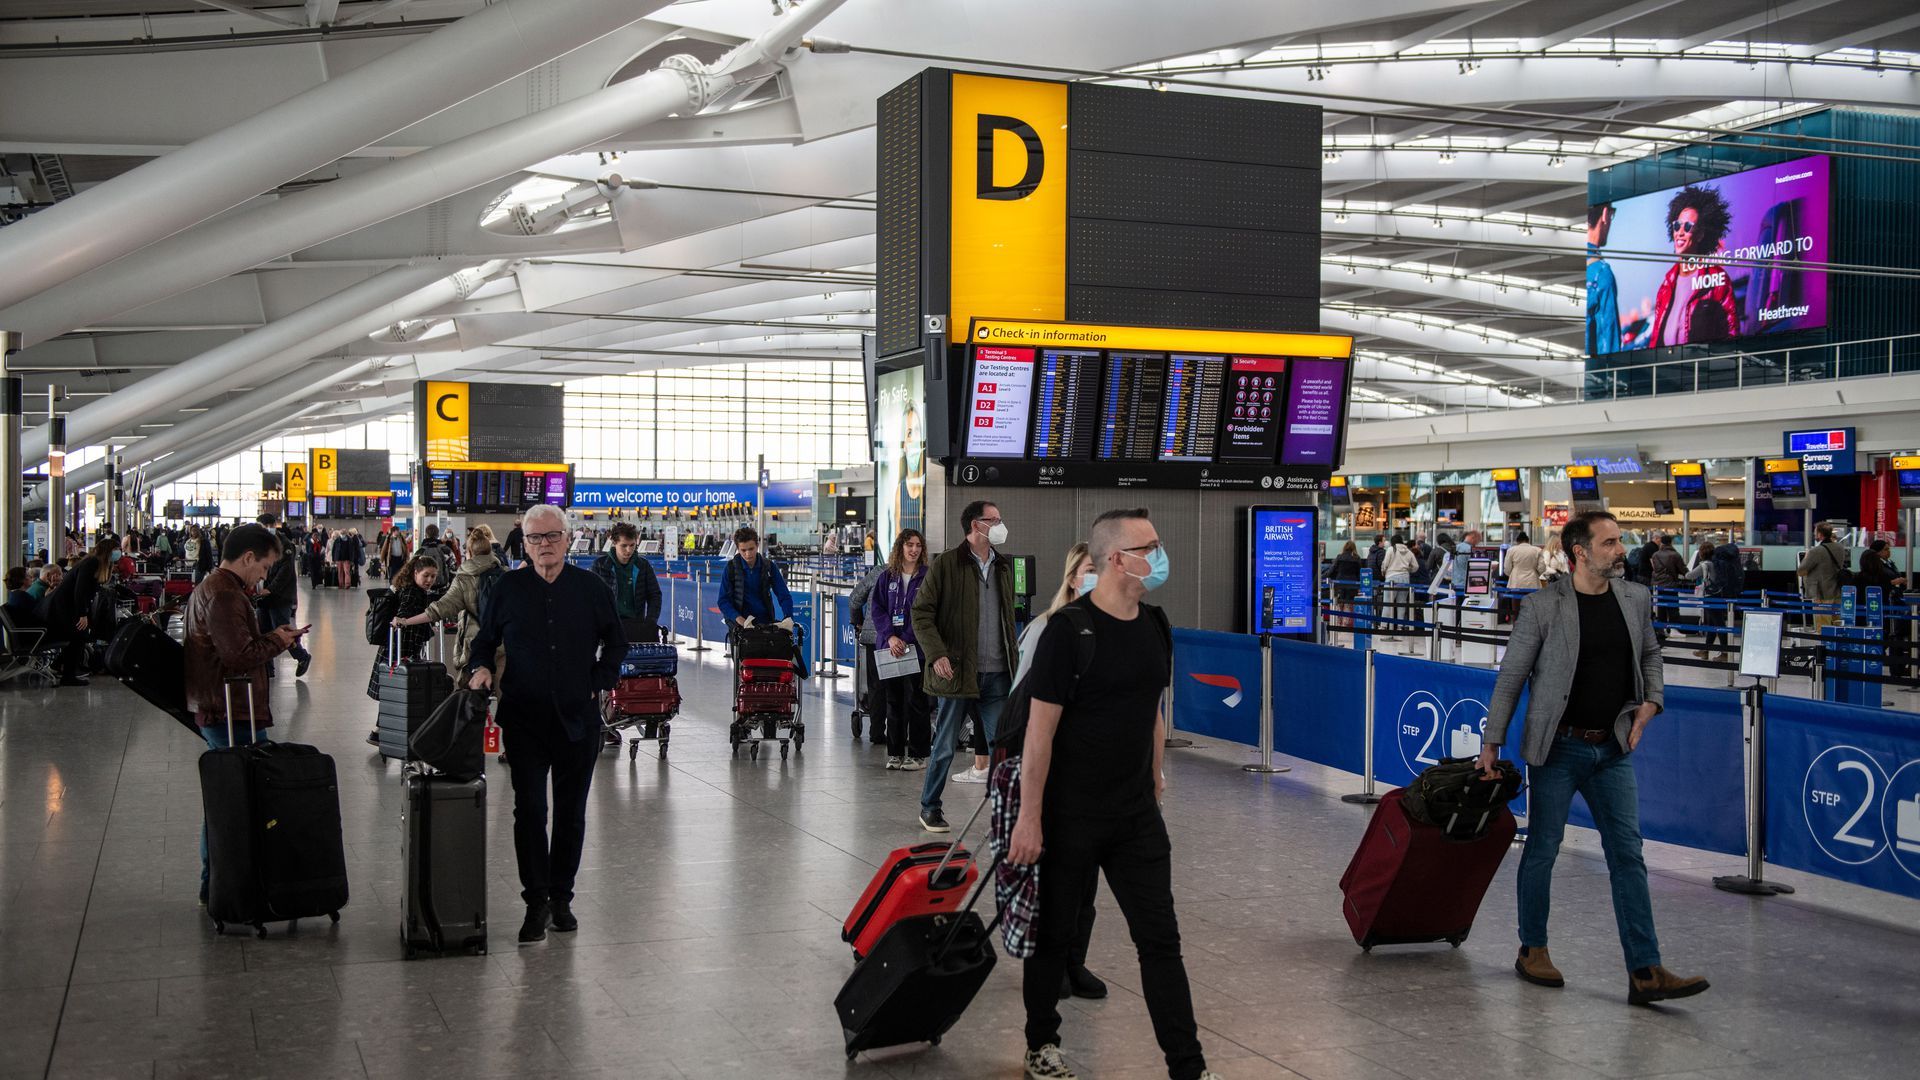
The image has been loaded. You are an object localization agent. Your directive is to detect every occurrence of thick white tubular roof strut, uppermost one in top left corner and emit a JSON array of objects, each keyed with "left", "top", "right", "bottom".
[{"left": 0, "top": 0, "right": 666, "bottom": 311}]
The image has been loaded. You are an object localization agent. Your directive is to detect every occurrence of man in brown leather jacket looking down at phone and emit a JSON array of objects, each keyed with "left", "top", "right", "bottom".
[{"left": 184, "top": 525, "right": 307, "bottom": 903}]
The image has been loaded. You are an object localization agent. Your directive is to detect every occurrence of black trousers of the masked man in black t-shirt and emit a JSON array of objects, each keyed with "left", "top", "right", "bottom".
[{"left": 1021, "top": 809, "right": 1206, "bottom": 1080}]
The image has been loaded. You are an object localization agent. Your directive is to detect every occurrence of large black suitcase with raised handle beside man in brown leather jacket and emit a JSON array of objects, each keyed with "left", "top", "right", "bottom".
[{"left": 200, "top": 682, "right": 348, "bottom": 938}]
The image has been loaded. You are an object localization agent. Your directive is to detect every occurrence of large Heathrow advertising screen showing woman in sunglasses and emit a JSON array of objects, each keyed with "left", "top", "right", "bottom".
[{"left": 1586, "top": 158, "right": 1832, "bottom": 356}]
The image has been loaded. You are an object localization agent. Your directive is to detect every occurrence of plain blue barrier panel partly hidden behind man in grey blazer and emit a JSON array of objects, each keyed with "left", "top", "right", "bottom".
[{"left": 1567, "top": 686, "right": 1747, "bottom": 855}]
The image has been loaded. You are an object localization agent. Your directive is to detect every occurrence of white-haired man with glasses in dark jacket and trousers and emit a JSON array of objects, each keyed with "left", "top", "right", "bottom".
[{"left": 467, "top": 505, "right": 626, "bottom": 944}]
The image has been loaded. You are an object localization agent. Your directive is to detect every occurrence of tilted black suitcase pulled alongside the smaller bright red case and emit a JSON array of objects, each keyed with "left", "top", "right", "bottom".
[{"left": 833, "top": 859, "right": 1000, "bottom": 1061}]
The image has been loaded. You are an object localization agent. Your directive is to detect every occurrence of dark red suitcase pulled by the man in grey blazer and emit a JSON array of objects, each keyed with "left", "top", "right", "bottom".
[{"left": 1340, "top": 788, "right": 1515, "bottom": 951}]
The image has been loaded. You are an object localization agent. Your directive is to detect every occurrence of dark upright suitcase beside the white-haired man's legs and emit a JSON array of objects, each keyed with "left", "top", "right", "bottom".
[{"left": 399, "top": 773, "right": 486, "bottom": 961}]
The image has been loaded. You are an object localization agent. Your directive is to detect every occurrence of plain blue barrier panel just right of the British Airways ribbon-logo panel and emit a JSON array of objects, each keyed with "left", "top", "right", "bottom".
[{"left": 1256, "top": 638, "right": 1367, "bottom": 773}]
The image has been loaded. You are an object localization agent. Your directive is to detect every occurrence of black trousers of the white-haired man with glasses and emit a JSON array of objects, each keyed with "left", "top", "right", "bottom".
[{"left": 501, "top": 715, "right": 601, "bottom": 903}]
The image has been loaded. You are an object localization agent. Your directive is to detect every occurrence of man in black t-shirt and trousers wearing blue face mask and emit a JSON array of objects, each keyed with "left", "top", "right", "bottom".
[{"left": 1006, "top": 509, "right": 1217, "bottom": 1080}]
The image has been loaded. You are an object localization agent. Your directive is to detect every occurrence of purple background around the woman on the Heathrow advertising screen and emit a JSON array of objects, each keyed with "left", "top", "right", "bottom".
[{"left": 1588, "top": 158, "right": 1832, "bottom": 354}]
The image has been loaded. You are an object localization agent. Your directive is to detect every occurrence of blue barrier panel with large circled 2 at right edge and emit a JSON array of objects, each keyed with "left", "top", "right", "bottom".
[{"left": 1764, "top": 696, "right": 1920, "bottom": 899}]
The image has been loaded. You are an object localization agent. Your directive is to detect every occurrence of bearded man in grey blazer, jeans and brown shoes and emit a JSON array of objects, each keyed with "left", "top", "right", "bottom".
[{"left": 1480, "top": 511, "right": 1707, "bottom": 1005}]
